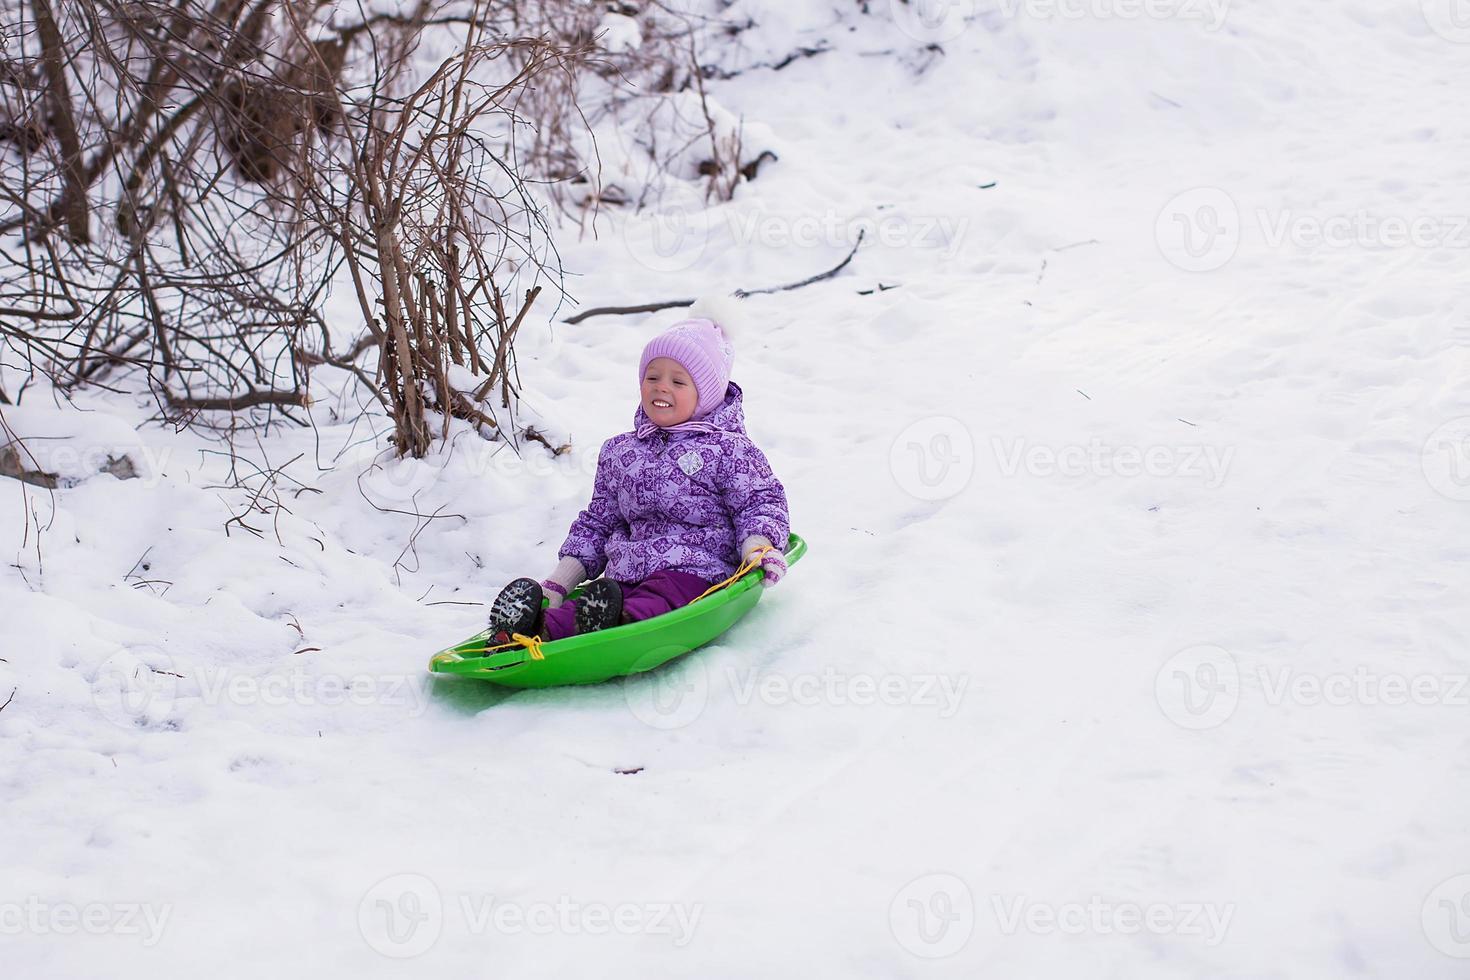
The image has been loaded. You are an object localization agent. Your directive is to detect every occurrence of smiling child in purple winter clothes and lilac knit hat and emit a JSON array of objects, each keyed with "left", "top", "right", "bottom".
[{"left": 490, "top": 300, "right": 791, "bottom": 645}]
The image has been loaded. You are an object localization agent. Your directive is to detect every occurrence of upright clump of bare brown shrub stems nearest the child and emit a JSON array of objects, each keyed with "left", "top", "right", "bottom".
[{"left": 326, "top": 31, "right": 576, "bottom": 455}]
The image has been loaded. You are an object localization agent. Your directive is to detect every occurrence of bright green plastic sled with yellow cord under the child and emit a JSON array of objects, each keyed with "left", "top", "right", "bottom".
[{"left": 429, "top": 535, "right": 807, "bottom": 688}]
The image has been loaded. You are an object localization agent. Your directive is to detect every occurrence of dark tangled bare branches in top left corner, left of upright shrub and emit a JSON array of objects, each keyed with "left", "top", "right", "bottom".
[{"left": 0, "top": 0, "right": 355, "bottom": 419}]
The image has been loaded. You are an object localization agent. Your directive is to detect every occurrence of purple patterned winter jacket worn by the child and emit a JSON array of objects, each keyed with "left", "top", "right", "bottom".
[{"left": 557, "top": 382, "right": 791, "bottom": 583}]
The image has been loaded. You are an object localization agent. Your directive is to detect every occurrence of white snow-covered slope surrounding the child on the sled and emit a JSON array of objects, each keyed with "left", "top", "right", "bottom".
[{"left": 0, "top": 0, "right": 1470, "bottom": 980}]
